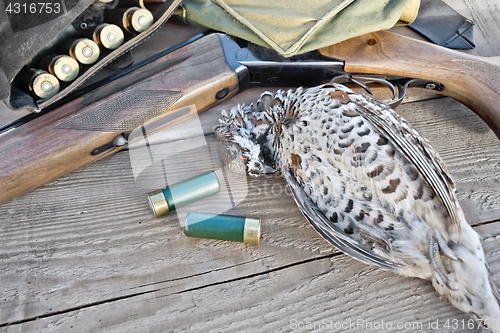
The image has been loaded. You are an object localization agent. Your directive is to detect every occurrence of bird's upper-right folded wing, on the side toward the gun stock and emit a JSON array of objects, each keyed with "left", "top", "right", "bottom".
[{"left": 349, "top": 93, "right": 462, "bottom": 240}]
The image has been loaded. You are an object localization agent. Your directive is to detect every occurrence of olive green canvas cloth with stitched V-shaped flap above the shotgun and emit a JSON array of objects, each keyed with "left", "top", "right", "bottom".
[{"left": 182, "top": 0, "right": 420, "bottom": 57}]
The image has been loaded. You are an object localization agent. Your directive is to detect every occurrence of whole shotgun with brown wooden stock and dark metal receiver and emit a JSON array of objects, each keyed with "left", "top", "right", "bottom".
[{"left": 0, "top": 32, "right": 500, "bottom": 202}]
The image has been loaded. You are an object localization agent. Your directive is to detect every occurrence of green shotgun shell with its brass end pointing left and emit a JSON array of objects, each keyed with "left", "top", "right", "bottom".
[{"left": 148, "top": 171, "right": 220, "bottom": 216}]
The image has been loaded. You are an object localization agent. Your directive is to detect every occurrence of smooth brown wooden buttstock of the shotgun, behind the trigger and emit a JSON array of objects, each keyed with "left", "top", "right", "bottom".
[{"left": 320, "top": 31, "right": 500, "bottom": 139}]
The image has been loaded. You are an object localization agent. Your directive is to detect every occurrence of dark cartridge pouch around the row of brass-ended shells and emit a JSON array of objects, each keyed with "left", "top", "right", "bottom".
[{"left": 0, "top": 0, "right": 181, "bottom": 112}]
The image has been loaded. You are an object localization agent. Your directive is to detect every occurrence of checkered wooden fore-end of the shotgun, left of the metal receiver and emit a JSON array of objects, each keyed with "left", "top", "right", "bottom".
[{"left": 0, "top": 34, "right": 238, "bottom": 202}]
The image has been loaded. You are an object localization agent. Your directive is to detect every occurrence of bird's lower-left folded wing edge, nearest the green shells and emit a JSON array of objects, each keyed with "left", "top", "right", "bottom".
[{"left": 284, "top": 169, "right": 401, "bottom": 272}]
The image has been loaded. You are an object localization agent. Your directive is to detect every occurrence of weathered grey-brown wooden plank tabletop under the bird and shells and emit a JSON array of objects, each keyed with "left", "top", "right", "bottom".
[{"left": 0, "top": 0, "right": 500, "bottom": 332}]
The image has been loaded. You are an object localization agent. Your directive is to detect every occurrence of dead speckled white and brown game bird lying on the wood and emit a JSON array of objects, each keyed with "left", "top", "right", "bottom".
[{"left": 216, "top": 84, "right": 500, "bottom": 326}]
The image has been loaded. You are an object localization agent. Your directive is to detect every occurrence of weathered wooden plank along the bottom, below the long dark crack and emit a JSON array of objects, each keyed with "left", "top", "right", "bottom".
[{"left": 2, "top": 242, "right": 498, "bottom": 332}]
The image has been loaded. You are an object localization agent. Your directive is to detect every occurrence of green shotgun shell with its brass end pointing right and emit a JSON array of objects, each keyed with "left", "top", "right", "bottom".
[{"left": 184, "top": 212, "right": 261, "bottom": 245}]
